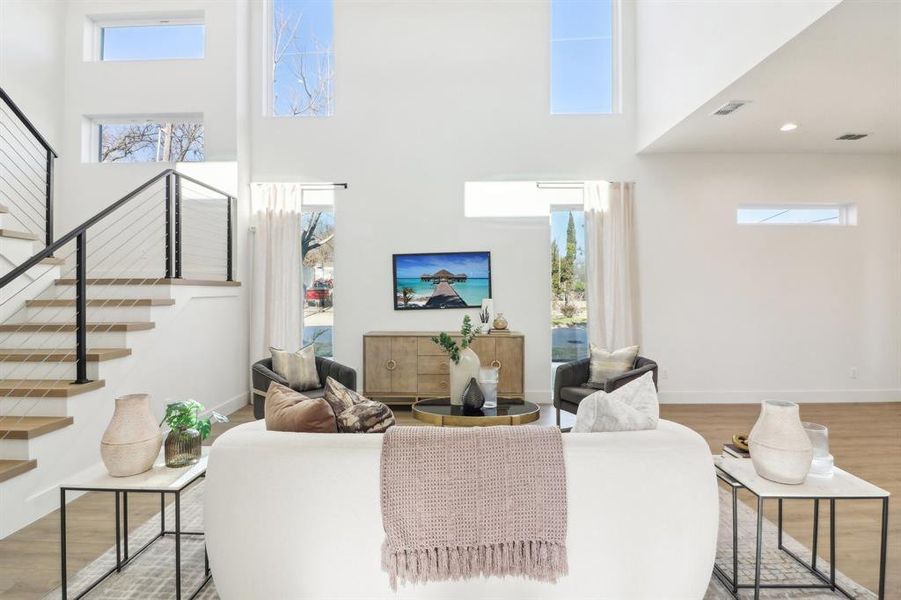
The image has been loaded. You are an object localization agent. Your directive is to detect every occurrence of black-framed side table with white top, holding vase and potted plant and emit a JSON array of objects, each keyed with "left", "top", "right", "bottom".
[{"left": 59, "top": 448, "right": 211, "bottom": 600}]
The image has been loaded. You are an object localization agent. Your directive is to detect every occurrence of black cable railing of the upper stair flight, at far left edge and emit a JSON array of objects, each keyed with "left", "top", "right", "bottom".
[{"left": 0, "top": 88, "right": 59, "bottom": 246}]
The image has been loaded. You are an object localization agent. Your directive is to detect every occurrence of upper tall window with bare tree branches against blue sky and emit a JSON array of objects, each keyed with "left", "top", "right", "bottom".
[{"left": 269, "top": 0, "right": 335, "bottom": 117}]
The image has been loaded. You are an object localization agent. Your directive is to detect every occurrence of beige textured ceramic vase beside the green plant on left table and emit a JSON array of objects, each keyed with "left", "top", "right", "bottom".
[{"left": 100, "top": 394, "right": 163, "bottom": 477}]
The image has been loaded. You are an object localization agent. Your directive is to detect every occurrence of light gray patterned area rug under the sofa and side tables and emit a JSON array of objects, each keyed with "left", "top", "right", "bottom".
[{"left": 45, "top": 480, "right": 876, "bottom": 600}]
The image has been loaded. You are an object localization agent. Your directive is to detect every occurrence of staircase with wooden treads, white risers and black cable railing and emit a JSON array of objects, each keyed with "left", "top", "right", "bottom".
[{"left": 0, "top": 83, "right": 240, "bottom": 538}]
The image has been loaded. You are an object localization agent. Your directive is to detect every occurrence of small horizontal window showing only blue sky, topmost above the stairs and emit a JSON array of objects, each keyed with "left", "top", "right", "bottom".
[{"left": 91, "top": 17, "right": 206, "bottom": 61}]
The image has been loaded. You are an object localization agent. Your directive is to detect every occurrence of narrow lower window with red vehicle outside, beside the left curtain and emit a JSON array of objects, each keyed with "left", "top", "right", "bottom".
[{"left": 301, "top": 189, "right": 335, "bottom": 357}]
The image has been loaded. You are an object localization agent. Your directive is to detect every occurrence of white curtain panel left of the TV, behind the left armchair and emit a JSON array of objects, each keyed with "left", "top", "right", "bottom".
[{"left": 250, "top": 183, "right": 303, "bottom": 361}]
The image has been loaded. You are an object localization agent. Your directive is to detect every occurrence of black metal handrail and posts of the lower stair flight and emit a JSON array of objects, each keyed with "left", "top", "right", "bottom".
[{"left": 0, "top": 169, "right": 235, "bottom": 383}]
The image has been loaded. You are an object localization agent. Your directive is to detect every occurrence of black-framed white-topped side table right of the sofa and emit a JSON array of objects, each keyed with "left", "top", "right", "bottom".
[{"left": 713, "top": 457, "right": 889, "bottom": 600}]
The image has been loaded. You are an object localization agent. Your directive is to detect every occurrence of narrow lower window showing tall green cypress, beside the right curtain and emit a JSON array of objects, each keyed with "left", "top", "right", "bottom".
[{"left": 551, "top": 206, "right": 588, "bottom": 362}]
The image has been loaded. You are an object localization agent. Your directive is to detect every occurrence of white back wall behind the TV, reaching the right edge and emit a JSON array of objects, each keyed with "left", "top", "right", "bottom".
[{"left": 251, "top": 2, "right": 901, "bottom": 401}]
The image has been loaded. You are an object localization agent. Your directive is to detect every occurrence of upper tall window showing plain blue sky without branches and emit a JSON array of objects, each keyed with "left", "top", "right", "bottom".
[{"left": 551, "top": 0, "right": 616, "bottom": 114}]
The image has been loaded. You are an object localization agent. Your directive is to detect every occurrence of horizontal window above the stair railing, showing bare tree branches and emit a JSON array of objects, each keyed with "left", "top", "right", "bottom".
[{"left": 91, "top": 117, "right": 204, "bottom": 163}]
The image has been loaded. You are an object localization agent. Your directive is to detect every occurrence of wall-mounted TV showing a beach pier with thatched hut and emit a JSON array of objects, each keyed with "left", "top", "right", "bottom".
[{"left": 394, "top": 252, "right": 491, "bottom": 309}]
